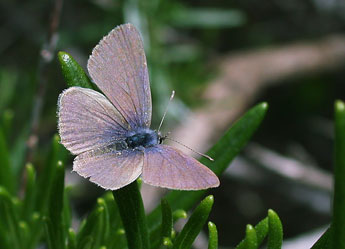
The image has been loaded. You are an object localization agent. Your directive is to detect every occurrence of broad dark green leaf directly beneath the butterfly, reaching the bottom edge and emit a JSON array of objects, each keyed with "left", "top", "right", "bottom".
[{"left": 113, "top": 181, "right": 150, "bottom": 249}]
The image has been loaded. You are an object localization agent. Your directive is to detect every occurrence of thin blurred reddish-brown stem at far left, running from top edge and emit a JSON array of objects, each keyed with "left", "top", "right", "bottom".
[{"left": 27, "top": 0, "right": 63, "bottom": 161}]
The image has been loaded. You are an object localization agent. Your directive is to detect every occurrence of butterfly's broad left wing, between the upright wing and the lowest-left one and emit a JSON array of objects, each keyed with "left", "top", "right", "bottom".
[{"left": 58, "top": 87, "right": 128, "bottom": 154}]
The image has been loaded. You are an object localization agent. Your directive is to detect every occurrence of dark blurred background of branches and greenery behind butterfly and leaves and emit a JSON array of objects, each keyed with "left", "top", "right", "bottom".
[{"left": 0, "top": 0, "right": 345, "bottom": 249}]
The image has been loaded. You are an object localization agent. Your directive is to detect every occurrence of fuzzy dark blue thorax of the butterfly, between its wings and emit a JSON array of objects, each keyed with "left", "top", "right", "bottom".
[{"left": 125, "top": 129, "right": 160, "bottom": 149}]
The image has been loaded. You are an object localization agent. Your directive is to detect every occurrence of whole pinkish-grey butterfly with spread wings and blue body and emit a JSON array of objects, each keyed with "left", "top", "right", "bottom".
[{"left": 58, "top": 24, "right": 219, "bottom": 190}]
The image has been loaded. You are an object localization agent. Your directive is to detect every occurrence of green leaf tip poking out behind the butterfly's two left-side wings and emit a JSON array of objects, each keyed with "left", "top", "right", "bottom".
[{"left": 58, "top": 51, "right": 93, "bottom": 89}]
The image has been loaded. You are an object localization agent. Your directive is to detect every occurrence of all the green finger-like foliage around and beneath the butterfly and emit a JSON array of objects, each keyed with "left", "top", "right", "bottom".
[{"left": 0, "top": 49, "right": 345, "bottom": 249}]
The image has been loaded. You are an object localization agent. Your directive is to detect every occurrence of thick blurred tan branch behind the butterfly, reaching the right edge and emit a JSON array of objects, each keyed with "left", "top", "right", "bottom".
[{"left": 172, "top": 35, "right": 345, "bottom": 154}]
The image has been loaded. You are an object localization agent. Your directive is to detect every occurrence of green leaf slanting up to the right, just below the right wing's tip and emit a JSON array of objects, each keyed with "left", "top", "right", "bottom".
[{"left": 173, "top": 195, "right": 214, "bottom": 249}]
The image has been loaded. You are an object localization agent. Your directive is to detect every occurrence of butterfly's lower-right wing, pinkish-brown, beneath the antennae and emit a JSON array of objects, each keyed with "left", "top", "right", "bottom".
[{"left": 142, "top": 145, "right": 219, "bottom": 190}]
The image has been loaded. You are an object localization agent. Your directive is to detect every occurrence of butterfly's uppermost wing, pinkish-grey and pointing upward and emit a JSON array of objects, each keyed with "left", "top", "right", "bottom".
[{"left": 87, "top": 24, "right": 152, "bottom": 129}]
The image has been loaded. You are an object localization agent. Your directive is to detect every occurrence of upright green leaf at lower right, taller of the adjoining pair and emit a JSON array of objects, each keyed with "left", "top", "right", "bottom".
[{"left": 267, "top": 209, "right": 283, "bottom": 249}]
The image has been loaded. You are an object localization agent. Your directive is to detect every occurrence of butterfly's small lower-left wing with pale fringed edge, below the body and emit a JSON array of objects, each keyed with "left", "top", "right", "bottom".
[{"left": 73, "top": 147, "right": 143, "bottom": 190}]
